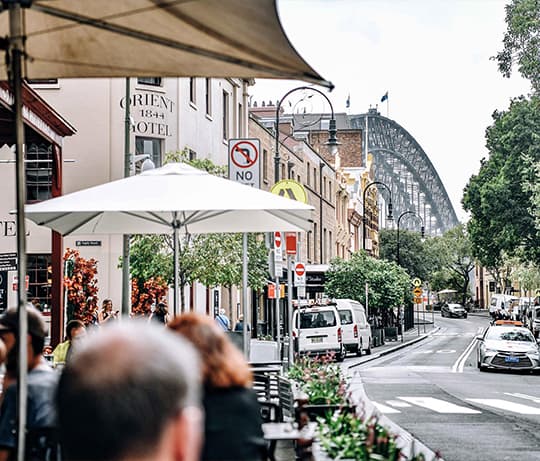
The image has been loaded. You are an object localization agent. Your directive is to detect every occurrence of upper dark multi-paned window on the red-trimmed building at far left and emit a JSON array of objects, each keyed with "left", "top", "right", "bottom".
[{"left": 25, "top": 144, "right": 53, "bottom": 202}]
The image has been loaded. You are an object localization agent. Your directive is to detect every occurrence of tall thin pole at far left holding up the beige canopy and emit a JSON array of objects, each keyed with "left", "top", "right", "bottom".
[{"left": 8, "top": 2, "right": 28, "bottom": 461}]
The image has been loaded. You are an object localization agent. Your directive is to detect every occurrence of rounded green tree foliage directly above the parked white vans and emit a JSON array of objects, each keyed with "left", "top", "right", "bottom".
[{"left": 324, "top": 251, "right": 411, "bottom": 310}]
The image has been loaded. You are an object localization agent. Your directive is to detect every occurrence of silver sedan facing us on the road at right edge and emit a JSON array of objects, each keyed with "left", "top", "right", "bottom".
[{"left": 477, "top": 322, "right": 540, "bottom": 371}]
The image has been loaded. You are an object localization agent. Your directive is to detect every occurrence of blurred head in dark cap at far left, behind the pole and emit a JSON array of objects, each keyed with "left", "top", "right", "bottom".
[{"left": 0, "top": 304, "right": 47, "bottom": 365}]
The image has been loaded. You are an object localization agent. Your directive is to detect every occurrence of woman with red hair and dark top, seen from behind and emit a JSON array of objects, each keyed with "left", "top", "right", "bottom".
[{"left": 169, "top": 313, "right": 266, "bottom": 461}]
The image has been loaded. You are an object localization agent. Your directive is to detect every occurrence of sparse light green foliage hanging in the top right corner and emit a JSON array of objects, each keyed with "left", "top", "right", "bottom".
[{"left": 494, "top": 0, "right": 540, "bottom": 94}]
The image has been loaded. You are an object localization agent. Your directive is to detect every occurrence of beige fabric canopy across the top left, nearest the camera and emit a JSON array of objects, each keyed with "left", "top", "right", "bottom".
[{"left": 0, "top": 0, "right": 331, "bottom": 86}]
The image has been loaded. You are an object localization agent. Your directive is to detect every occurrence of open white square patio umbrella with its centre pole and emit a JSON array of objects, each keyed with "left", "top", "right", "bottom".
[{"left": 25, "top": 163, "right": 313, "bottom": 312}]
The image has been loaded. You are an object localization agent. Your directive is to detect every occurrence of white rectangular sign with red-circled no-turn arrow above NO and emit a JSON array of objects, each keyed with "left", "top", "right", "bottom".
[{"left": 229, "top": 139, "right": 261, "bottom": 189}]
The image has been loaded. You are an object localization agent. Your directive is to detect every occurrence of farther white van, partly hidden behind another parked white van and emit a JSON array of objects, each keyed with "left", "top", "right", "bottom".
[{"left": 334, "top": 299, "right": 371, "bottom": 356}]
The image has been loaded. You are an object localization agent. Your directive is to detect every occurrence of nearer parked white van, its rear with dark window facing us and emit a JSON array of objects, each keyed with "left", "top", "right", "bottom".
[{"left": 293, "top": 305, "right": 345, "bottom": 362}]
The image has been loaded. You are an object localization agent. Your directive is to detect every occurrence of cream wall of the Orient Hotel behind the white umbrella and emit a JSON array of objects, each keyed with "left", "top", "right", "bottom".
[{"left": 0, "top": 78, "right": 248, "bottom": 312}]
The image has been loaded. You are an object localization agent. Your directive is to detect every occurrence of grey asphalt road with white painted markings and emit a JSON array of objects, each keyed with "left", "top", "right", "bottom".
[{"left": 351, "top": 316, "right": 540, "bottom": 461}]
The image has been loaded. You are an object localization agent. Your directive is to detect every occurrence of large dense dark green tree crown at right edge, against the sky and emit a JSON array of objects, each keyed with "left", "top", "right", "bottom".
[{"left": 463, "top": 96, "right": 540, "bottom": 271}]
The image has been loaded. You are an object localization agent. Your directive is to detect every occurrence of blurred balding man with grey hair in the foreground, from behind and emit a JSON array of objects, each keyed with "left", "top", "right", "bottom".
[{"left": 56, "top": 321, "right": 202, "bottom": 461}]
